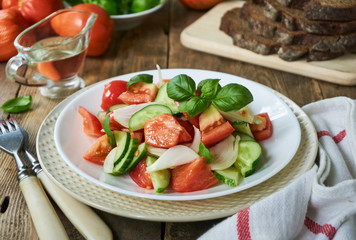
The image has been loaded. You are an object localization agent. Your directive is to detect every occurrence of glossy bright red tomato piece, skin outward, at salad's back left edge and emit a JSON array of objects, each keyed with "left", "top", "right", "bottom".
[{"left": 101, "top": 80, "right": 127, "bottom": 111}]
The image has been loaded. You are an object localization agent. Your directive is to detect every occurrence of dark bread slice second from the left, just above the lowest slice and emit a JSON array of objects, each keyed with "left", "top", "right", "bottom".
[{"left": 241, "top": 1, "right": 356, "bottom": 53}]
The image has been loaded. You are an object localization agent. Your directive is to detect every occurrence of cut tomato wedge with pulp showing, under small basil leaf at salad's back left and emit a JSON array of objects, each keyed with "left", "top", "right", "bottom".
[{"left": 119, "top": 82, "right": 158, "bottom": 105}]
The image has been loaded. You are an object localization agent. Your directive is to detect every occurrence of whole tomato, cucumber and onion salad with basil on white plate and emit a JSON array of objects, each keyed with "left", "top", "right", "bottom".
[{"left": 78, "top": 74, "right": 273, "bottom": 193}]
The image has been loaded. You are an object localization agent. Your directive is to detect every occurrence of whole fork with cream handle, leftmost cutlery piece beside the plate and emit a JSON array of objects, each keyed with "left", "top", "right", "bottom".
[{"left": 0, "top": 119, "right": 69, "bottom": 239}]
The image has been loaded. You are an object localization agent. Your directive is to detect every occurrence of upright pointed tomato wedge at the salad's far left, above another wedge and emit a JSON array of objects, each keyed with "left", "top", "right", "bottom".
[{"left": 78, "top": 106, "right": 105, "bottom": 137}]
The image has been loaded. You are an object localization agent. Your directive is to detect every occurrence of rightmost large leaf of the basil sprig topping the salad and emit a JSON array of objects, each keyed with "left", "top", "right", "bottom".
[{"left": 212, "top": 83, "right": 253, "bottom": 112}]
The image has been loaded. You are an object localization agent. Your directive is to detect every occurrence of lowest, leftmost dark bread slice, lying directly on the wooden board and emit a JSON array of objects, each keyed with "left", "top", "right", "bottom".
[{"left": 220, "top": 8, "right": 343, "bottom": 61}]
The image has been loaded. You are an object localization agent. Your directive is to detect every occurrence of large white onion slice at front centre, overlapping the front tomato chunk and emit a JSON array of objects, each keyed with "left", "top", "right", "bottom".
[{"left": 147, "top": 145, "right": 199, "bottom": 172}]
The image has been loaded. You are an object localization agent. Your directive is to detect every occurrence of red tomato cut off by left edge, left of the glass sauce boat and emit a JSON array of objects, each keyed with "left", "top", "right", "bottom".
[{"left": 0, "top": 8, "right": 28, "bottom": 61}]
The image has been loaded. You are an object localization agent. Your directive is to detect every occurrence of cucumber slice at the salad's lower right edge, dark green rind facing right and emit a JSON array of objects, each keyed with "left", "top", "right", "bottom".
[{"left": 234, "top": 141, "right": 262, "bottom": 177}]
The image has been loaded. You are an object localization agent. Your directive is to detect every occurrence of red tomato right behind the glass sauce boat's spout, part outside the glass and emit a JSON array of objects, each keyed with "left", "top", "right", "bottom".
[{"left": 73, "top": 3, "right": 114, "bottom": 56}]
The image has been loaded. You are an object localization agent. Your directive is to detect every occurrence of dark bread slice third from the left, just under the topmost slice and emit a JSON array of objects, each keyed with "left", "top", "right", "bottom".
[{"left": 264, "top": 0, "right": 356, "bottom": 35}]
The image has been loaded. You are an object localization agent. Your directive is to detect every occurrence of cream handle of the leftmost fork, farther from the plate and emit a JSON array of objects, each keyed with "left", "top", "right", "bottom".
[{"left": 19, "top": 176, "right": 69, "bottom": 239}]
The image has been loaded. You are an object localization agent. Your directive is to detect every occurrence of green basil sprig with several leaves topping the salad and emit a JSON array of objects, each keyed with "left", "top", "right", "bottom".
[{"left": 167, "top": 74, "right": 253, "bottom": 118}]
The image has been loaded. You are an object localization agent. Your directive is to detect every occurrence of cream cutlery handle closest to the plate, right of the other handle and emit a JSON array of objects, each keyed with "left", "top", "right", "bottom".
[{"left": 37, "top": 171, "right": 113, "bottom": 240}]
